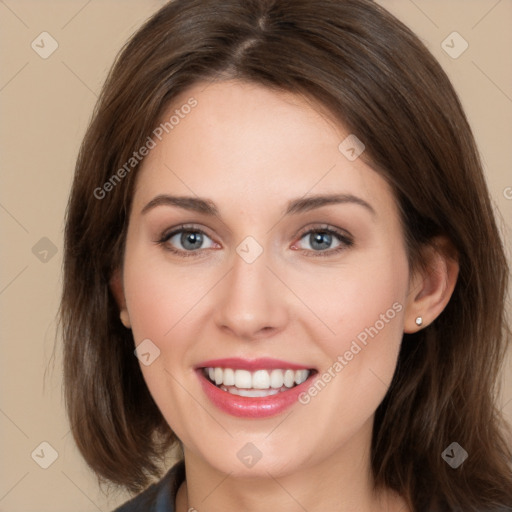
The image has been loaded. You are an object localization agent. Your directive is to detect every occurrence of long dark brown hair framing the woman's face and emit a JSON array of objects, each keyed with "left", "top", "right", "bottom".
[{"left": 61, "top": 0, "right": 512, "bottom": 512}]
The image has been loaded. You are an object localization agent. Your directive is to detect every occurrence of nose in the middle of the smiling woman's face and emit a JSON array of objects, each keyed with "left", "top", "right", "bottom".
[{"left": 215, "top": 247, "right": 289, "bottom": 341}]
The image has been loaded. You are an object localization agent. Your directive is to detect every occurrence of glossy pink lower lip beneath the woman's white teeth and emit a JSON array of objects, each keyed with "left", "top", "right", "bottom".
[{"left": 196, "top": 369, "right": 312, "bottom": 418}]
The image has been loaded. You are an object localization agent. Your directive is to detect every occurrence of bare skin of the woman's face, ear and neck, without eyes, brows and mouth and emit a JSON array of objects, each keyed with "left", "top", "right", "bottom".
[{"left": 112, "top": 81, "right": 457, "bottom": 512}]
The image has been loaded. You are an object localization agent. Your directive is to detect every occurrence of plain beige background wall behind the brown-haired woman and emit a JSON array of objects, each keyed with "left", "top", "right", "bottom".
[{"left": 0, "top": 0, "right": 512, "bottom": 512}]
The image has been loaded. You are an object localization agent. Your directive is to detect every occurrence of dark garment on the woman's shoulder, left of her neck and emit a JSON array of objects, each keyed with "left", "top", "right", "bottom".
[{"left": 113, "top": 461, "right": 185, "bottom": 512}]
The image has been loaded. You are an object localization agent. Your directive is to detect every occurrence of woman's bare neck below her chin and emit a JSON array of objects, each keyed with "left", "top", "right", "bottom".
[{"left": 176, "top": 418, "right": 408, "bottom": 512}]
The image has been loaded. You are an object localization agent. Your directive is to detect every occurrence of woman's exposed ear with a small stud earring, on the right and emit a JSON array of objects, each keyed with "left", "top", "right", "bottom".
[{"left": 404, "top": 236, "right": 459, "bottom": 333}]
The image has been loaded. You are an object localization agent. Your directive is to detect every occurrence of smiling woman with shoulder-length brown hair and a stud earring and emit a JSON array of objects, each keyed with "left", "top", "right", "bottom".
[{"left": 61, "top": 0, "right": 512, "bottom": 512}]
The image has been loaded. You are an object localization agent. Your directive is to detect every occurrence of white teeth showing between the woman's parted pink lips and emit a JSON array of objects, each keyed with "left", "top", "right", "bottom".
[{"left": 202, "top": 367, "right": 316, "bottom": 398}]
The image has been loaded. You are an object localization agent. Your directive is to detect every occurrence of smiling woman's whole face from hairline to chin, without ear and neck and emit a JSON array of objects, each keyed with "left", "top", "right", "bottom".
[{"left": 119, "top": 81, "right": 416, "bottom": 476}]
